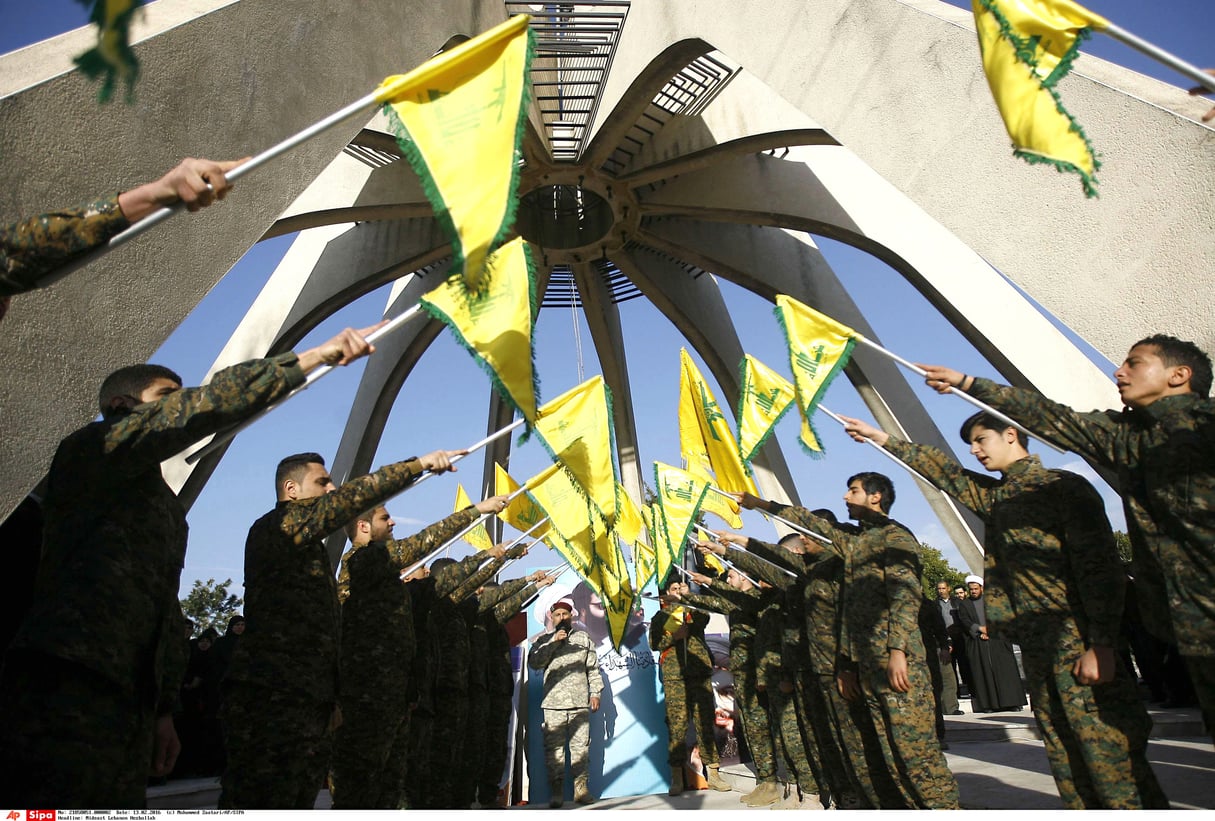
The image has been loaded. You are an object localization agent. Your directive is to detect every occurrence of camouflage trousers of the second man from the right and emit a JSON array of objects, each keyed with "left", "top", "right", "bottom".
[{"left": 1021, "top": 635, "right": 1169, "bottom": 810}]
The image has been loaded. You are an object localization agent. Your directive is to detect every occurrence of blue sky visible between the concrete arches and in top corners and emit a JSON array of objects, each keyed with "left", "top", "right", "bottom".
[{"left": 0, "top": 0, "right": 1215, "bottom": 590}]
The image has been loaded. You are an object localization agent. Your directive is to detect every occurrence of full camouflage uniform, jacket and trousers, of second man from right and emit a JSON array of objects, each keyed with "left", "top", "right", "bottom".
[{"left": 886, "top": 437, "right": 1169, "bottom": 809}]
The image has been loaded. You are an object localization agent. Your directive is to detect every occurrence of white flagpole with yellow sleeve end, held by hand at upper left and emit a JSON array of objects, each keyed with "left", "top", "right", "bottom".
[{"left": 39, "top": 15, "right": 527, "bottom": 287}]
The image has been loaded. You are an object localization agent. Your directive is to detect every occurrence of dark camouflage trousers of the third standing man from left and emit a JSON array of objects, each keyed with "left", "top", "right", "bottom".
[{"left": 330, "top": 685, "right": 408, "bottom": 810}]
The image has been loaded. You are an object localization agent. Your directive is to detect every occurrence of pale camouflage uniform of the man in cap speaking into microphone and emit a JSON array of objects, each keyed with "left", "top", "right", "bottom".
[{"left": 527, "top": 628, "right": 604, "bottom": 799}]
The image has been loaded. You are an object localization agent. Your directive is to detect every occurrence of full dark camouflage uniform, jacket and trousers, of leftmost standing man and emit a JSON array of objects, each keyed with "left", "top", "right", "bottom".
[{"left": 0, "top": 353, "right": 304, "bottom": 808}]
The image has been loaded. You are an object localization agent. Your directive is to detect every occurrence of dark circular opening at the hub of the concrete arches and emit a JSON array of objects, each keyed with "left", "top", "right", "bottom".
[{"left": 515, "top": 186, "right": 615, "bottom": 248}]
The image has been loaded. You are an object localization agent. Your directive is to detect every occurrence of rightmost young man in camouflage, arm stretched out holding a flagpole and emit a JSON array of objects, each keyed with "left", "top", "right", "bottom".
[{"left": 926, "top": 334, "right": 1215, "bottom": 736}]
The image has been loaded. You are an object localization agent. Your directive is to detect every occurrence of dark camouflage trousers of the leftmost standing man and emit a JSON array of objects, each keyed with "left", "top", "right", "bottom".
[{"left": 0, "top": 651, "right": 156, "bottom": 809}]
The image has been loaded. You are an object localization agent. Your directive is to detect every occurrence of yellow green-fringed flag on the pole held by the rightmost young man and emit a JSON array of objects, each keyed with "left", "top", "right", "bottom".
[{"left": 776, "top": 294, "right": 857, "bottom": 458}]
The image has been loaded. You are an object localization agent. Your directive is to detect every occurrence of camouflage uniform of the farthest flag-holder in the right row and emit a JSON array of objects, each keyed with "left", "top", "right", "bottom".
[{"left": 683, "top": 583, "right": 780, "bottom": 783}]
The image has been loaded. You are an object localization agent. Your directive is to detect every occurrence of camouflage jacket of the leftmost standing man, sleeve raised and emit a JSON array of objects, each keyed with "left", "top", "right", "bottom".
[{"left": 12, "top": 353, "right": 304, "bottom": 710}]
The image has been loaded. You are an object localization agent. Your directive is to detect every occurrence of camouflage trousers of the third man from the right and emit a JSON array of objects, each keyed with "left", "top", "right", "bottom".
[{"left": 860, "top": 657, "right": 957, "bottom": 810}]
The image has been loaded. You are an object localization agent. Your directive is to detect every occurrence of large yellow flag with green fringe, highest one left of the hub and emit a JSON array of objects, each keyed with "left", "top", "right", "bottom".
[{"left": 377, "top": 15, "right": 535, "bottom": 291}]
